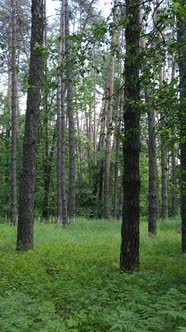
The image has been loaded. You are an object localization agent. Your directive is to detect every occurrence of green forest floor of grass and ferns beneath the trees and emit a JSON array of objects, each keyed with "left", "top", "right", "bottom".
[{"left": 0, "top": 219, "right": 186, "bottom": 332}]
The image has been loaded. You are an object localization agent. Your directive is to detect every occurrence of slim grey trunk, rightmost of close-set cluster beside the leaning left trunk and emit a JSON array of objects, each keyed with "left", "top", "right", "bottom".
[{"left": 65, "top": 0, "right": 76, "bottom": 219}]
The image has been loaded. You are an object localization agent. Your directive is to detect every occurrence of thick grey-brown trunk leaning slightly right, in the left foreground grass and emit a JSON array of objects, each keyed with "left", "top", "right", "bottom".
[{"left": 17, "top": 0, "right": 44, "bottom": 250}]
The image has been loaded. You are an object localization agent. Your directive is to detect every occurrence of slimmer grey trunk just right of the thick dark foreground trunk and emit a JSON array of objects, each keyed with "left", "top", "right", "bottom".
[{"left": 145, "top": 91, "right": 158, "bottom": 235}]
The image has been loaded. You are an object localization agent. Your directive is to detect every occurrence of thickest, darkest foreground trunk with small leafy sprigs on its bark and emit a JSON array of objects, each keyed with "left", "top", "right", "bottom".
[{"left": 120, "top": 0, "right": 140, "bottom": 272}]
